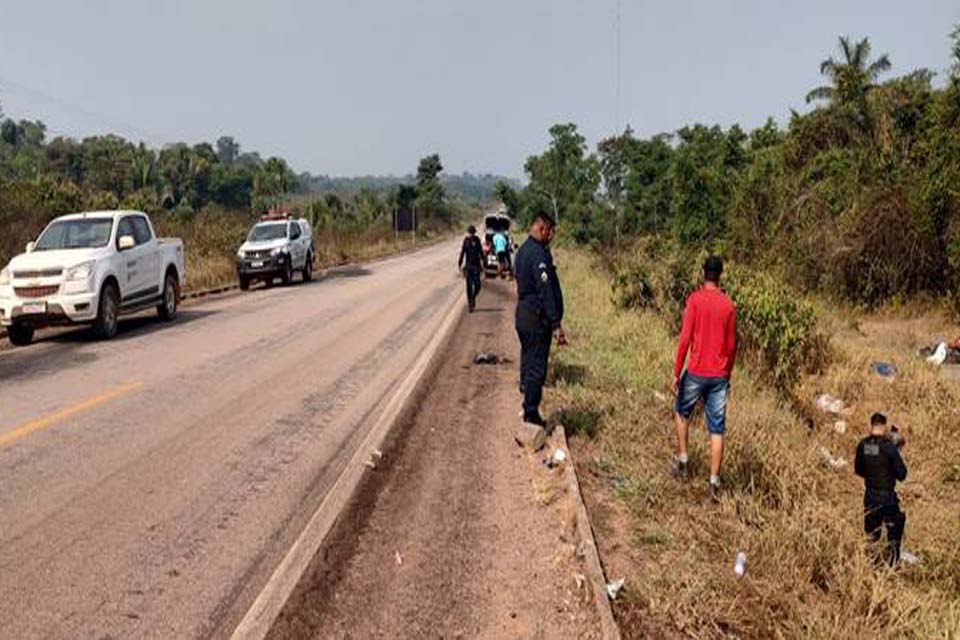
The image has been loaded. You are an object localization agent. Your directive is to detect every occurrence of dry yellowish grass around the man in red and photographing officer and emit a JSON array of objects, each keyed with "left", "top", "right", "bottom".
[{"left": 549, "top": 251, "right": 960, "bottom": 638}]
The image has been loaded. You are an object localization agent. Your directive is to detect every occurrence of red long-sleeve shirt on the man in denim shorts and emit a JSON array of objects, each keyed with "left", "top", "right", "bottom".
[{"left": 673, "top": 285, "right": 737, "bottom": 378}]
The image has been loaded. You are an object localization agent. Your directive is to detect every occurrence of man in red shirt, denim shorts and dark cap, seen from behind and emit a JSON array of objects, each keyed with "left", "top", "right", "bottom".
[{"left": 673, "top": 256, "right": 737, "bottom": 500}]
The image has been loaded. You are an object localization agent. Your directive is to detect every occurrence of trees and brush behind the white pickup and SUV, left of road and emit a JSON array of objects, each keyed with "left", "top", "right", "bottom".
[{"left": 0, "top": 110, "right": 497, "bottom": 288}]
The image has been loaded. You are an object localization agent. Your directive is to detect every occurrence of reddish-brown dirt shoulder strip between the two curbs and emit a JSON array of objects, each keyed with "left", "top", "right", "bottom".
[{"left": 270, "top": 283, "right": 599, "bottom": 638}]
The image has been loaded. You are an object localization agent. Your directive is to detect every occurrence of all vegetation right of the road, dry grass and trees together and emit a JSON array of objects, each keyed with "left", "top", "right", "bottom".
[{"left": 497, "top": 26, "right": 960, "bottom": 638}]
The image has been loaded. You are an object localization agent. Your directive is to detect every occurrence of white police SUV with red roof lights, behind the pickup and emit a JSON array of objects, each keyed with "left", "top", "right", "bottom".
[{"left": 237, "top": 211, "right": 314, "bottom": 291}]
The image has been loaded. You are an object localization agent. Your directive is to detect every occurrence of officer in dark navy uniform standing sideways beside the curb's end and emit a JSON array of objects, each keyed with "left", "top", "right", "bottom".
[{"left": 514, "top": 213, "right": 567, "bottom": 427}]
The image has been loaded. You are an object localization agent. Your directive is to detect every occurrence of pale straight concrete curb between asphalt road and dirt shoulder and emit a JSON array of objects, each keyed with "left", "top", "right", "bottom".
[{"left": 231, "top": 287, "right": 464, "bottom": 640}]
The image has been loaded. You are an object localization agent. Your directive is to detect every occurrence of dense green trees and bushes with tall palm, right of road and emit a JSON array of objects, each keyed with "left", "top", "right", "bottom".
[{"left": 496, "top": 26, "right": 960, "bottom": 304}]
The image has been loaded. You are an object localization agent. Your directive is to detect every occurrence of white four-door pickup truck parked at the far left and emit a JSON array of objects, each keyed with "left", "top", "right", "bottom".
[{"left": 0, "top": 211, "right": 186, "bottom": 346}]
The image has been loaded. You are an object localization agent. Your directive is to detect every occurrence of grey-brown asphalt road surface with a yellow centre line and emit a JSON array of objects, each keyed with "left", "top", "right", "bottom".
[{"left": 0, "top": 243, "right": 461, "bottom": 638}]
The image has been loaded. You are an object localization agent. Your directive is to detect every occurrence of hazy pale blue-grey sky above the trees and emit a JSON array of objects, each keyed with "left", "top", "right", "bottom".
[{"left": 0, "top": 0, "right": 960, "bottom": 177}]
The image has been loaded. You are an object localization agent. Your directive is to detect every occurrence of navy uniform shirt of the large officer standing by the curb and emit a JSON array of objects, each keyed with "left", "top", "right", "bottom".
[{"left": 514, "top": 237, "right": 563, "bottom": 331}]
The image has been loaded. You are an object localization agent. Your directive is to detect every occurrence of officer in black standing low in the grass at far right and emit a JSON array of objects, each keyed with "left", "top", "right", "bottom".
[{"left": 854, "top": 413, "right": 907, "bottom": 566}]
